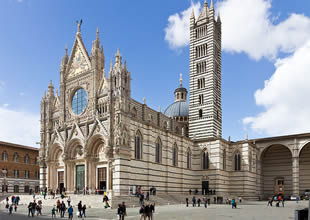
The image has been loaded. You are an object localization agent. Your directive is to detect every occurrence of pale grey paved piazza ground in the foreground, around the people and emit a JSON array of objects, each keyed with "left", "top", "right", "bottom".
[{"left": 0, "top": 201, "right": 308, "bottom": 220}]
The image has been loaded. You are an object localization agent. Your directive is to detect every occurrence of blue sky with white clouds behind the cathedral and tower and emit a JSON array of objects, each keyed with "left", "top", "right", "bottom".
[{"left": 0, "top": 0, "right": 310, "bottom": 146}]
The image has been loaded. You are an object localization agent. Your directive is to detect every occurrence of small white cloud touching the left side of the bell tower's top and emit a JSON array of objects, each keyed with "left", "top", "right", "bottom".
[{"left": 165, "top": 2, "right": 201, "bottom": 49}]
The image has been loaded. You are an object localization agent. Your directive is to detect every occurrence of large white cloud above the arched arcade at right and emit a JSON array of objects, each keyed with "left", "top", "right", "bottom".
[{"left": 243, "top": 40, "right": 310, "bottom": 135}]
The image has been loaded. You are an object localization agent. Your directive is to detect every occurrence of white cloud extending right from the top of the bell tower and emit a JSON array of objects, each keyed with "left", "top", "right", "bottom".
[{"left": 217, "top": 0, "right": 310, "bottom": 60}]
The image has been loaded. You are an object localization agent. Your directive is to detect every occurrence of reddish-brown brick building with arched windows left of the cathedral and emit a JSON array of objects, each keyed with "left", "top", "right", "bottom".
[{"left": 0, "top": 141, "right": 39, "bottom": 193}]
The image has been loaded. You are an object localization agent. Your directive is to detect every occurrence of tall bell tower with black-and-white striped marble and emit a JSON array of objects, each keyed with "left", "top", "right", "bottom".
[{"left": 189, "top": 0, "right": 222, "bottom": 140}]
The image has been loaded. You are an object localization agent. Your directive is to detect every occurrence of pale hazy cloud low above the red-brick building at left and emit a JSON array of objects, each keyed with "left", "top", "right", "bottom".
[{"left": 0, "top": 107, "right": 40, "bottom": 147}]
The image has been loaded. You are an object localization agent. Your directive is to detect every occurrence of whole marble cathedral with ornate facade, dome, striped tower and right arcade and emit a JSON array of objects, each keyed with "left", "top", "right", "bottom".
[{"left": 39, "top": 1, "right": 310, "bottom": 199}]
